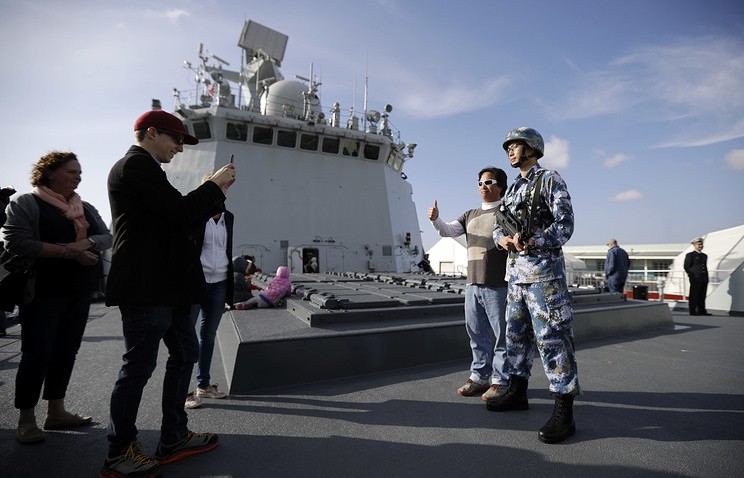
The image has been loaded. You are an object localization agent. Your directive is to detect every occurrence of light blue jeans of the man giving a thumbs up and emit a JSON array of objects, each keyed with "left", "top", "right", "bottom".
[{"left": 465, "top": 284, "right": 509, "bottom": 384}]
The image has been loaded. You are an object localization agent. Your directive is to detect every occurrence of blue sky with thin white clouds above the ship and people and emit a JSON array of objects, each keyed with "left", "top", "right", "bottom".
[{"left": 0, "top": 0, "right": 744, "bottom": 248}]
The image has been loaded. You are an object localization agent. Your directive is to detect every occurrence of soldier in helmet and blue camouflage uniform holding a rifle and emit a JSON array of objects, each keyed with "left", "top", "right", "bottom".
[{"left": 486, "top": 127, "right": 580, "bottom": 443}]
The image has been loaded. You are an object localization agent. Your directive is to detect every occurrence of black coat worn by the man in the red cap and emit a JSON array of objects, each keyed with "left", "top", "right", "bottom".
[{"left": 106, "top": 146, "right": 225, "bottom": 306}]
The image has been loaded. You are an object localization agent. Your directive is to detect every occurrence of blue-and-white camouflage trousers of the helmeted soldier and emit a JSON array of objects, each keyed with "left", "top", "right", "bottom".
[{"left": 506, "top": 279, "right": 581, "bottom": 395}]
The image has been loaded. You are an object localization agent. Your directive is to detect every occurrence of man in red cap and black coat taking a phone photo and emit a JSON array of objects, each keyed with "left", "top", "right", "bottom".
[{"left": 99, "top": 111, "right": 235, "bottom": 477}]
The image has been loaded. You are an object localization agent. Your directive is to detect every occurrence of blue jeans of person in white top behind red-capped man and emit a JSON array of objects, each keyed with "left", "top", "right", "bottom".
[{"left": 191, "top": 280, "right": 227, "bottom": 388}]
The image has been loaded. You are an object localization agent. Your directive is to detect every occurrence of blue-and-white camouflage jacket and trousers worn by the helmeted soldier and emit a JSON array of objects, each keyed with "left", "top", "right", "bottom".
[{"left": 493, "top": 164, "right": 581, "bottom": 395}]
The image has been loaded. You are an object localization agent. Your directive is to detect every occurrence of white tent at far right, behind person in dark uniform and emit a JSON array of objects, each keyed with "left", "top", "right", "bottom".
[{"left": 664, "top": 225, "right": 744, "bottom": 313}]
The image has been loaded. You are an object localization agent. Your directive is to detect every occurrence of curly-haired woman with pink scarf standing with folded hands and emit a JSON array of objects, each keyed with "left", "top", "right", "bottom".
[{"left": 3, "top": 151, "right": 112, "bottom": 444}]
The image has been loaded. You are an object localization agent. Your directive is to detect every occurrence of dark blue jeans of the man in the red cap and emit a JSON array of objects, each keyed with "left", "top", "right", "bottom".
[{"left": 108, "top": 305, "right": 199, "bottom": 454}]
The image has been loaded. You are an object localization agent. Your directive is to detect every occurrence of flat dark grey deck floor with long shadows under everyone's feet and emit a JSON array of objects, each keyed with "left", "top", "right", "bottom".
[{"left": 0, "top": 304, "right": 744, "bottom": 478}]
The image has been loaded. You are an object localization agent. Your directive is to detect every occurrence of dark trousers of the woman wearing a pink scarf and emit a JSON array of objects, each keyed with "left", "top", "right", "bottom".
[{"left": 15, "top": 293, "right": 91, "bottom": 410}]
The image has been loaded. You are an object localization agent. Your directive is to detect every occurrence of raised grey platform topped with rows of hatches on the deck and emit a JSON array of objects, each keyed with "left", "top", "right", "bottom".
[{"left": 218, "top": 273, "right": 674, "bottom": 395}]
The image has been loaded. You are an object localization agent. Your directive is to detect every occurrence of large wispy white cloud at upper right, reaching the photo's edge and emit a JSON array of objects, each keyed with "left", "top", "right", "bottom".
[{"left": 559, "top": 37, "right": 744, "bottom": 147}]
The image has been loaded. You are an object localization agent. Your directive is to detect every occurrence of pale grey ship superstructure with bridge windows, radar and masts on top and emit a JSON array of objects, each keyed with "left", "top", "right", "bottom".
[{"left": 160, "top": 21, "right": 423, "bottom": 273}]
